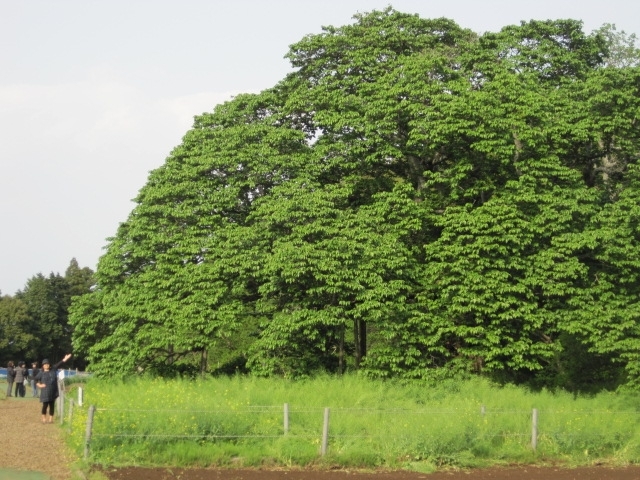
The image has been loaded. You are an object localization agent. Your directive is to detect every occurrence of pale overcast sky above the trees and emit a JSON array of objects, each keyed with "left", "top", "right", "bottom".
[{"left": 0, "top": 0, "right": 640, "bottom": 295}]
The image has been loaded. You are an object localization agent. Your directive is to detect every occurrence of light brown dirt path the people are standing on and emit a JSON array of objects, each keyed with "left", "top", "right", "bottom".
[{"left": 0, "top": 396, "right": 72, "bottom": 480}]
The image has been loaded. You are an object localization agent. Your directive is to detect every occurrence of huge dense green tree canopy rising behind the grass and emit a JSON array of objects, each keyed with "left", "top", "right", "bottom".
[{"left": 70, "top": 8, "right": 640, "bottom": 389}]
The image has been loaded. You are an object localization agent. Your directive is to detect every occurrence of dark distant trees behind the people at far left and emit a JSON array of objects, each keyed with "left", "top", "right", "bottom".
[{"left": 0, "top": 258, "right": 94, "bottom": 369}]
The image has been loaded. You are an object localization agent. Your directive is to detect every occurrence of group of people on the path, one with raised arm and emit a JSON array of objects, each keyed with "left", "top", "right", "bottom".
[{"left": 7, "top": 353, "right": 71, "bottom": 423}]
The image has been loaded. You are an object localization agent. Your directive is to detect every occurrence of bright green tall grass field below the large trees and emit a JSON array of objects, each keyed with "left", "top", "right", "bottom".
[{"left": 63, "top": 376, "right": 640, "bottom": 472}]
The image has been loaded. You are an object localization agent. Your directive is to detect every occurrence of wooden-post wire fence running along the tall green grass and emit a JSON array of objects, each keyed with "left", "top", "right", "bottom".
[{"left": 50, "top": 388, "right": 640, "bottom": 464}]
